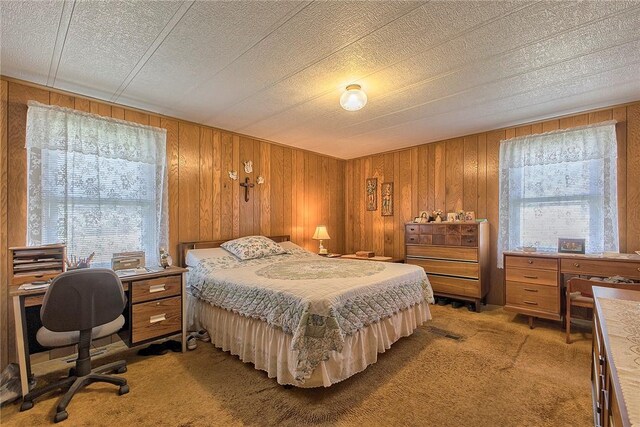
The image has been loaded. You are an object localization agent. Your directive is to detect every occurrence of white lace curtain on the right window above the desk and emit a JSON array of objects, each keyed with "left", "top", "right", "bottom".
[{"left": 498, "top": 121, "right": 618, "bottom": 268}]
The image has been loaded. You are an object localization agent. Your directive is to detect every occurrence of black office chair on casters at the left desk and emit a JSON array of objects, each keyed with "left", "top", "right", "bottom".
[{"left": 20, "top": 268, "right": 129, "bottom": 422}]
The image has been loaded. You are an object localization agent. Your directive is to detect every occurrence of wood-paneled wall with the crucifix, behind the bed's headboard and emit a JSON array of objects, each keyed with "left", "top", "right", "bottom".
[{"left": 0, "top": 79, "right": 345, "bottom": 367}]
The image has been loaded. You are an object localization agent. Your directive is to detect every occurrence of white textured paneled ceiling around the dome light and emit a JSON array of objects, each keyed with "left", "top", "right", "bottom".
[{"left": 0, "top": 0, "right": 640, "bottom": 158}]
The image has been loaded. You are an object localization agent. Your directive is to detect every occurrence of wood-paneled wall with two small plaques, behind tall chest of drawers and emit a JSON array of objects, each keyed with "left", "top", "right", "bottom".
[{"left": 345, "top": 102, "right": 640, "bottom": 304}]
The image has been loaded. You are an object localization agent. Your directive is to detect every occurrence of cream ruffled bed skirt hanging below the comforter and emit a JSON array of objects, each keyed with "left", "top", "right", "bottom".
[{"left": 187, "top": 295, "right": 431, "bottom": 388}]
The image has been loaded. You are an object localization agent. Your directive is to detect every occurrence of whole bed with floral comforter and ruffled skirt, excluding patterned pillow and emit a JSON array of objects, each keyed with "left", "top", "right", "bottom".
[{"left": 180, "top": 236, "right": 433, "bottom": 388}]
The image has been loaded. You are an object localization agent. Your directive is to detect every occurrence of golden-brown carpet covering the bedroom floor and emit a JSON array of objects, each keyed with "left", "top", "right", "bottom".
[{"left": 1, "top": 306, "right": 593, "bottom": 426}]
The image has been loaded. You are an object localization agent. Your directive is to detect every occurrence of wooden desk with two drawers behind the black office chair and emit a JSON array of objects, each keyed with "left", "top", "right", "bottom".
[{"left": 9, "top": 267, "right": 187, "bottom": 396}]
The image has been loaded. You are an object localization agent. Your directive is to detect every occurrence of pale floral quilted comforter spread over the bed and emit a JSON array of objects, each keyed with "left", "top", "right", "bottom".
[{"left": 188, "top": 249, "right": 433, "bottom": 381}]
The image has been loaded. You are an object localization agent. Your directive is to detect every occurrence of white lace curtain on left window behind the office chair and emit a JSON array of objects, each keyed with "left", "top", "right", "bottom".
[{"left": 26, "top": 102, "right": 168, "bottom": 267}]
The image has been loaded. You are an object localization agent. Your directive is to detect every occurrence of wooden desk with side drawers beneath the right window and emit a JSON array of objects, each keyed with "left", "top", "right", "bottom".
[{"left": 504, "top": 251, "right": 640, "bottom": 325}]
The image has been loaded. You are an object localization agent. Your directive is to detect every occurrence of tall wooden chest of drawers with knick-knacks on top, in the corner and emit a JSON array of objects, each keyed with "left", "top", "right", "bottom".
[{"left": 405, "top": 222, "right": 489, "bottom": 311}]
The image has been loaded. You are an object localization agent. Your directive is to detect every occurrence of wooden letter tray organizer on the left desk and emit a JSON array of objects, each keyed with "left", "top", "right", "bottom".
[{"left": 9, "top": 244, "right": 67, "bottom": 285}]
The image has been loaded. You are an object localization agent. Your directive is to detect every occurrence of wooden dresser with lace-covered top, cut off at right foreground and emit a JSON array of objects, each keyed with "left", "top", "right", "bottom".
[{"left": 591, "top": 286, "right": 640, "bottom": 427}]
